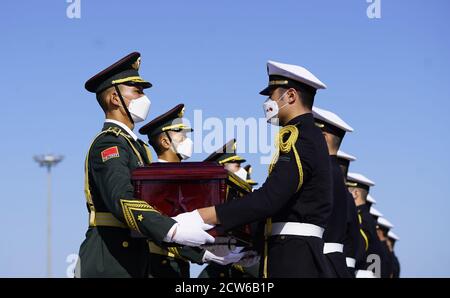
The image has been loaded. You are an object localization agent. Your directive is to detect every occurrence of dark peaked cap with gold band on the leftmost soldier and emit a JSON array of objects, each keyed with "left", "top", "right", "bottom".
[{"left": 84, "top": 52, "right": 152, "bottom": 93}]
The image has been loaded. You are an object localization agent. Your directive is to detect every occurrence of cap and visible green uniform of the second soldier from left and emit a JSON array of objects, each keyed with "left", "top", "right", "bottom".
[{"left": 139, "top": 104, "right": 205, "bottom": 278}]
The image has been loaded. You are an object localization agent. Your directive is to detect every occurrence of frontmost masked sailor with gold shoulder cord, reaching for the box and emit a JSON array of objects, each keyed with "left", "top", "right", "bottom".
[{"left": 187, "top": 61, "right": 332, "bottom": 277}]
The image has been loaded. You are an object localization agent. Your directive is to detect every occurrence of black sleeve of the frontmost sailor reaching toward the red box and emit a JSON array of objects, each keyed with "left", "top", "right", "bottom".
[{"left": 216, "top": 146, "right": 310, "bottom": 231}]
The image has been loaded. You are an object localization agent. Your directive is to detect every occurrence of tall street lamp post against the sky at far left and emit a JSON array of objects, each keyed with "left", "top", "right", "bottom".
[{"left": 34, "top": 154, "right": 63, "bottom": 277}]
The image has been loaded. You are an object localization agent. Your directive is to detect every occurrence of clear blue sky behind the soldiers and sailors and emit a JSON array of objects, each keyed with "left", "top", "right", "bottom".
[{"left": 0, "top": 0, "right": 450, "bottom": 277}]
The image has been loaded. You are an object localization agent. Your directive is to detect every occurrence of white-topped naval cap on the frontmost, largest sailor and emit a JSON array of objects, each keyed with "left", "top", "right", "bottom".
[{"left": 260, "top": 60, "right": 327, "bottom": 95}]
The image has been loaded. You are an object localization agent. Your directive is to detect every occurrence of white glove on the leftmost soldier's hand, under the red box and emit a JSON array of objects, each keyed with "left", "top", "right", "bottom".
[{"left": 169, "top": 223, "right": 214, "bottom": 246}]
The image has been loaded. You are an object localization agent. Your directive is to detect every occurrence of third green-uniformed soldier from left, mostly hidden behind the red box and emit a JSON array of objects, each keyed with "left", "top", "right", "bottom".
[{"left": 198, "top": 139, "right": 258, "bottom": 278}]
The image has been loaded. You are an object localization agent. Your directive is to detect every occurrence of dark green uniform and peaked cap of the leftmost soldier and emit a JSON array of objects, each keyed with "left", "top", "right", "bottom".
[{"left": 78, "top": 53, "right": 176, "bottom": 277}]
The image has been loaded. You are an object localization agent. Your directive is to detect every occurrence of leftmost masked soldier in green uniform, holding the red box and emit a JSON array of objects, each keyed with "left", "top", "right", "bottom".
[{"left": 77, "top": 52, "right": 214, "bottom": 277}]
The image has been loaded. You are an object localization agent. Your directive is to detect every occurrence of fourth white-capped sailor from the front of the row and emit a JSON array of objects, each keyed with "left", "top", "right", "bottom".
[{"left": 347, "top": 173, "right": 383, "bottom": 277}]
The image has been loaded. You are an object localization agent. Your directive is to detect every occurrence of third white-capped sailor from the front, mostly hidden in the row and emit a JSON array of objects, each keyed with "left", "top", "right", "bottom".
[{"left": 337, "top": 150, "right": 365, "bottom": 277}]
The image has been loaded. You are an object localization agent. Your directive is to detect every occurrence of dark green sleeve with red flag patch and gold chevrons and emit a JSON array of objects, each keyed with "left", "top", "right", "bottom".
[{"left": 90, "top": 135, "right": 176, "bottom": 243}]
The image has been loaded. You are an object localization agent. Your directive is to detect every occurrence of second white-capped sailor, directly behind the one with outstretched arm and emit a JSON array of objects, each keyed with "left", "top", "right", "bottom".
[{"left": 313, "top": 107, "right": 354, "bottom": 278}]
